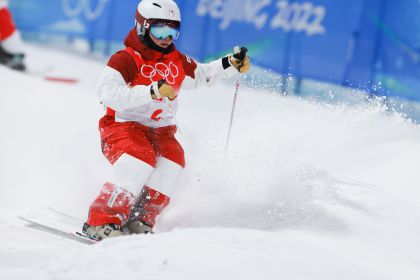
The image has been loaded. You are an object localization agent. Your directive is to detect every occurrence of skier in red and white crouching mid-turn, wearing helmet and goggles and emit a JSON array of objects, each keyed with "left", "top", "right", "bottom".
[{"left": 83, "top": 0, "right": 250, "bottom": 240}]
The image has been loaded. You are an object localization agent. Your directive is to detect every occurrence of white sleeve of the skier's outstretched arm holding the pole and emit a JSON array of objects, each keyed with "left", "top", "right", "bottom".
[{"left": 181, "top": 58, "right": 239, "bottom": 89}]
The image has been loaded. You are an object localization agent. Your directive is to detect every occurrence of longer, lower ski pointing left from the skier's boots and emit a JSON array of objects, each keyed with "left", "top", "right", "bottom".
[{"left": 18, "top": 216, "right": 98, "bottom": 245}]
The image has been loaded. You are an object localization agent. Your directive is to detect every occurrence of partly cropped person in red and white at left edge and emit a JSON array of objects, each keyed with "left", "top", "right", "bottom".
[{"left": 0, "top": 0, "right": 26, "bottom": 71}]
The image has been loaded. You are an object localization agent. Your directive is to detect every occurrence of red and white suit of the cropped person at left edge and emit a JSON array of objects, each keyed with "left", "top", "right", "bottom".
[{"left": 0, "top": 0, "right": 23, "bottom": 54}]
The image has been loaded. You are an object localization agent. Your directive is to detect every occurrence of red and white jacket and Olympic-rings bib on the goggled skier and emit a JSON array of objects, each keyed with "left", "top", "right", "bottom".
[{"left": 98, "top": 29, "right": 239, "bottom": 128}]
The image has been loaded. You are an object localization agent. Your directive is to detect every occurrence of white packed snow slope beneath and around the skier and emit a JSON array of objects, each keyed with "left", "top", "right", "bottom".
[{"left": 0, "top": 46, "right": 420, "bottom": 280}]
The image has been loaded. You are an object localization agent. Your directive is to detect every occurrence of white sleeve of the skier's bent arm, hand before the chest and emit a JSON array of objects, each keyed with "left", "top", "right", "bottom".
[{"left": 97, "top": 66, "right": 153, "bottom": 111}]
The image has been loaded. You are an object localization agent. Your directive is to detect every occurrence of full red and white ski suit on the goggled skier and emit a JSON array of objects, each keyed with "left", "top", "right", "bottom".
[{"left": 87, "top": 29, "right": 239, "bottom": 227}]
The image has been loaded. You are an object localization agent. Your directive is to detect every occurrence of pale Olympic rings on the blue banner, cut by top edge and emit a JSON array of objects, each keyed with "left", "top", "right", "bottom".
[{"left": 61, "top": 0, "right": 109, "bottom": 20}]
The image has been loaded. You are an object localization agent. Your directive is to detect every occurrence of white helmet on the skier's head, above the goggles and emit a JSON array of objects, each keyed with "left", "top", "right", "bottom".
[{"left": 135, "top": 0, "right": 181, "bottom": 41}]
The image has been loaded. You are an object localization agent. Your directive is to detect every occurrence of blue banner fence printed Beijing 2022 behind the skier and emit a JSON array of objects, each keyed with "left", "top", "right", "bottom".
[{"left": 11, "top": 0, "right": 420, "bottom": 101}]
